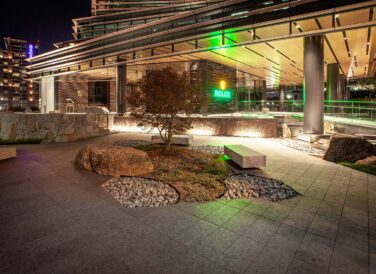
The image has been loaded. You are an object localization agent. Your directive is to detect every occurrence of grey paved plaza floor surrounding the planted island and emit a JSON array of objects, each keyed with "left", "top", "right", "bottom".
[{"left": 0, "top": 134, "right": 376, "bottom": 273}]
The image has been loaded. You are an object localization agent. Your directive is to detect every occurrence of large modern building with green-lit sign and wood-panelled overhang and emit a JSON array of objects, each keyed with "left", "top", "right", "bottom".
[{"left": 30, "top": 0, "right": 376, "bottom": 133}]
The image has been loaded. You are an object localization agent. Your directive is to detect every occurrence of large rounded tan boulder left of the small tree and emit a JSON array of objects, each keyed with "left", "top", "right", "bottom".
[{"left": 75, "top": 145, "right": 154, "bottom": 177}]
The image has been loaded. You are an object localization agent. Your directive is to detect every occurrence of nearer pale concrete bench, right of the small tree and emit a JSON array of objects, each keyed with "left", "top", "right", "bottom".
[{"left": 225, "top": 145, "right": 266, "bottom": 168}]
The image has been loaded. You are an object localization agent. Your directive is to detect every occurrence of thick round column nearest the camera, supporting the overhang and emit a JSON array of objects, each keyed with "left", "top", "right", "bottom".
[{"left": 304, "top": 35, "right": 324, "bottom": 134}]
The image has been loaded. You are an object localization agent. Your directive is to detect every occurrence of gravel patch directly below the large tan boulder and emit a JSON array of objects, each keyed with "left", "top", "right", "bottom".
[{"left": 102, "top": 177, "right": 179, "bottom": 207}]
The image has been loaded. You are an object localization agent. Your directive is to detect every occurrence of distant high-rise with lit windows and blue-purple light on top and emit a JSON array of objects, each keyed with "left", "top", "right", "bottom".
[{"left": 0, "top": 38, "right": 39, "bottom": 111}]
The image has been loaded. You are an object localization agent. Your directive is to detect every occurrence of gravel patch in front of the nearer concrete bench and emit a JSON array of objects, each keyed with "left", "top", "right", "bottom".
[{"left": 222, "top": 174, "right": 300, "bottom": 202}]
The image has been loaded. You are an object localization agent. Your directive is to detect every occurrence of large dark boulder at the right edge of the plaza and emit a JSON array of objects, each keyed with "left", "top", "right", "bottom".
[{"left": 324, "top": 136, "right": 376, "bottom": 163}]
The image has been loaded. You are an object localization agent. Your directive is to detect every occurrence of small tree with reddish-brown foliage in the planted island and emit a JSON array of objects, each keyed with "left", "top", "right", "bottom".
[{"left": 128, "top": 67, "right": 200, "bottom": 149}]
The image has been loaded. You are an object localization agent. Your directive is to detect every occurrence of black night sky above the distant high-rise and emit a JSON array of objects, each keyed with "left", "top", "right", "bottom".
[{"left": 0, "top": 0, "right": 91, "bottom": 52}]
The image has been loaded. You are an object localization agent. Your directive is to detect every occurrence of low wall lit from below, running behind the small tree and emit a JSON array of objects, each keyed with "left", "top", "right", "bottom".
[{"left": 113, "top": 117, "right": 281, "bottom": 138}]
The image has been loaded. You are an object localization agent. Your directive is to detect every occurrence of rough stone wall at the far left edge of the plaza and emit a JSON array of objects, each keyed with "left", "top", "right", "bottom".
[{"left": 0, "top": 113, "right": 114, "bottom": 143}]
